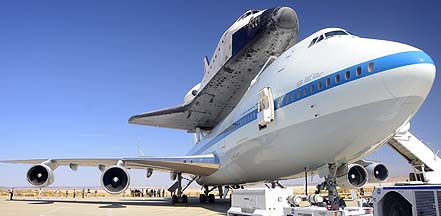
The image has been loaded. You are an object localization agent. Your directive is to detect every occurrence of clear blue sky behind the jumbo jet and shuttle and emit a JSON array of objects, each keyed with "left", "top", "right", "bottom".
[{"left": 0, "top": 0, "right": 441, "bottom": 186}]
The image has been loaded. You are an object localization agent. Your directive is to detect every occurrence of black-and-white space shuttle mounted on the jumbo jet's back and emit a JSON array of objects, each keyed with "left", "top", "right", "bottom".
[{"left": 129, "top": 7, "right": 299, "bottom": 133}]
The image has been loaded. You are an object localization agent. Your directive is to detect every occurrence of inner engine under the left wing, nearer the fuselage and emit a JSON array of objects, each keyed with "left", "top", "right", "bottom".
[{"left": 101, "top": 166, "right": 130, "bottom": 194}]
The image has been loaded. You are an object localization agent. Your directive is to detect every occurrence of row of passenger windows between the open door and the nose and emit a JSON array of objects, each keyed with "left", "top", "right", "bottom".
[{"left": 278, "top": 62, "right": 375, "bottom": 107}]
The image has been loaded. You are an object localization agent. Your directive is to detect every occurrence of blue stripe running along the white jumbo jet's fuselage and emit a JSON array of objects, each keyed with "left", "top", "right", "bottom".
[{"left": 189, "top": 51, "right": 434, "bottom": 155}]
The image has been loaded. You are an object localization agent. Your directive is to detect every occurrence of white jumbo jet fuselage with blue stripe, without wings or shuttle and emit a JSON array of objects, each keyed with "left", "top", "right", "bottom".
[{"left": 189, "top": 29, "right": 435, "bottom": 185}]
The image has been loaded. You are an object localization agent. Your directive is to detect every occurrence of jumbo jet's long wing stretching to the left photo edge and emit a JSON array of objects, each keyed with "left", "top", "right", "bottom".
[{"left": 0, "top": 154, "right": 219, "bottom": 176}]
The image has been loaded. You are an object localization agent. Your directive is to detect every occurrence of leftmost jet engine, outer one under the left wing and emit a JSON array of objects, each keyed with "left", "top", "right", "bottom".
[{"left": 26, "top": 164, "right": 54, "bottom": 187}]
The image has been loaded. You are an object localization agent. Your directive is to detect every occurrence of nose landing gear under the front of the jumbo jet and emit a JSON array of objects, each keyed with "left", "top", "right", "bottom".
[{"left": 315, "top": 164, "right": 346, "bottom": 210}]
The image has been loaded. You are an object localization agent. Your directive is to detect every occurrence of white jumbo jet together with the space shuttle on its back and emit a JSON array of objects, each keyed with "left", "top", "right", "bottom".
[{"left": 3, "top": 7, "right": 436, "bottom": 208}]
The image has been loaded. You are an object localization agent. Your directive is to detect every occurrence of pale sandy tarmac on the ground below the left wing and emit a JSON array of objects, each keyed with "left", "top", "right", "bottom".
[{"left": 0, "top": 197, "right": 230, "bottom": 216}]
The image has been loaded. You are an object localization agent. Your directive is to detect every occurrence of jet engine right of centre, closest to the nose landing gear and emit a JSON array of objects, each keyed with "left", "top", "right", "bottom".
[{"left": 337, "top": 164, "right": 368, "bottom": 188}]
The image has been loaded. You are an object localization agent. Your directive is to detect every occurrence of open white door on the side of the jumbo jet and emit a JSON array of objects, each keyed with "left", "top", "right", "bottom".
[{"left": 257, "top": 87, "right": 274, "bottom": 130}]
